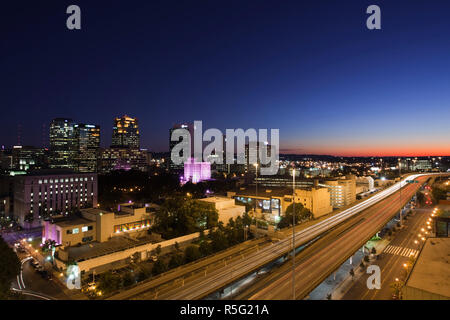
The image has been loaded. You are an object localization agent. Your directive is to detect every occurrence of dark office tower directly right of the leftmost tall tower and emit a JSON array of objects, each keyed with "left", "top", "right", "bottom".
[{"left": 74, "top": 124, "right": 100, "bottom": 172}]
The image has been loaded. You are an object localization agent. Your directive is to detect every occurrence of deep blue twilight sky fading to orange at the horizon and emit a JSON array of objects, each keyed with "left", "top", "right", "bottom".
[{"left": 0, "top": 0, "right": 450, "bottom": 156}]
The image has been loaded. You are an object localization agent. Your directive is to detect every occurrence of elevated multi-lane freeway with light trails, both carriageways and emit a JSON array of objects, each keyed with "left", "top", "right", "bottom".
[{"left": 145, "top": 174, "right": 442, "bottom": 300}]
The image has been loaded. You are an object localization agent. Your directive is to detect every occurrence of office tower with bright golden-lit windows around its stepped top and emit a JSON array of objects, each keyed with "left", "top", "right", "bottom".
[{"left": 111, "top": 115, "right": 140, "bottom": 149}]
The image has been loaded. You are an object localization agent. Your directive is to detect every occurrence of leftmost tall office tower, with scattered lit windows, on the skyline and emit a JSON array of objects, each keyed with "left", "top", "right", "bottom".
[{"left": 49, "top": 118, "right": 77, "bottom": 169}]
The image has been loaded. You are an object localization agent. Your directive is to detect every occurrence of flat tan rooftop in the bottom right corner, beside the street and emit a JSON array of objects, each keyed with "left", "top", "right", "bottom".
[{"left": 406, "top": 238, "right": 450, "bottom": 298}]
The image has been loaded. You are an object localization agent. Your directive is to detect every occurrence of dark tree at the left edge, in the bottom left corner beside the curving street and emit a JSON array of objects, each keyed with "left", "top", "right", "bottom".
[{"left": 0, "top": 237, "right": 20, "bottom": 300}]
